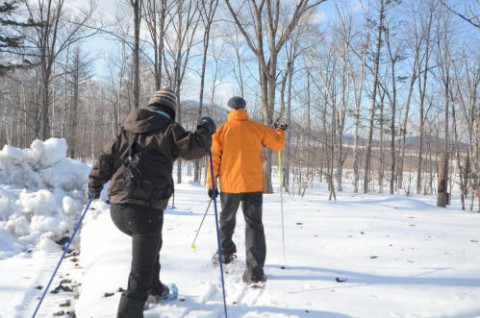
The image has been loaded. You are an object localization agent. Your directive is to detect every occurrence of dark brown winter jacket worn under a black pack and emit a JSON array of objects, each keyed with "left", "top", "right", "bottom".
[{"left": 88, "top": 108, "right": 212, "bottom": 210}]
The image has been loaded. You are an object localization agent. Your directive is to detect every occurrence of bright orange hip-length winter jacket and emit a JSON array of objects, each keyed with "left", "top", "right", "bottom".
[{"left": 208, "top": 109, "right": 285, "bottom": 193}]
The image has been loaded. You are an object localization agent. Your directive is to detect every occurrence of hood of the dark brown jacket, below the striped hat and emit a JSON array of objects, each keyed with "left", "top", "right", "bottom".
[{"left": 123, "top": 108, "right": 172, "bottom": 134}]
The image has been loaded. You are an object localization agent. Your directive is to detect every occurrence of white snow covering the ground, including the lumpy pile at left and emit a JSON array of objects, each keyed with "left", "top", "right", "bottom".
[{"left": 0, "top": 139, "right": 480, "bottom": 318}]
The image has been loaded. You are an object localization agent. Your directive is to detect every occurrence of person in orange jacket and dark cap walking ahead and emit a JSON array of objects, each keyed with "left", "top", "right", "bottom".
[{"left": 208, "top": 97, "right": 287, "bottom": 283}]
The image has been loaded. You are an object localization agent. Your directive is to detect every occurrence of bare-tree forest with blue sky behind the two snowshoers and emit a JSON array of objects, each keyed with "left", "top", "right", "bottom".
[{"left": 0, "top": 0, "right": 480, "bottom": 210}]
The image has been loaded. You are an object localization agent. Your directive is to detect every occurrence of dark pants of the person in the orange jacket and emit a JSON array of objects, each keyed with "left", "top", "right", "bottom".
[{"left": 220, "top": 192, "right": 267, "bottom": 277}]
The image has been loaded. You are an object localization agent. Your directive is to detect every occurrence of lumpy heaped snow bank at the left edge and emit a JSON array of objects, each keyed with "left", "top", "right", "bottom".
[{"left": 0, "top": 138, "right": 90, "bottom": 251}]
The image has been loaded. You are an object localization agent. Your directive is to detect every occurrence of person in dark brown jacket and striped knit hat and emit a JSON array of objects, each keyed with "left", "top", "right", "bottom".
[{"left": 88, "top": 88, "right": 216, "bottom": 318}]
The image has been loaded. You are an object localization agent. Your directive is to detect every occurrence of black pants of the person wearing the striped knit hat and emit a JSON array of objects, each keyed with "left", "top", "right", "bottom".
[{"left": 110, "top": 204, "right": 163, "bottom": 318}]
